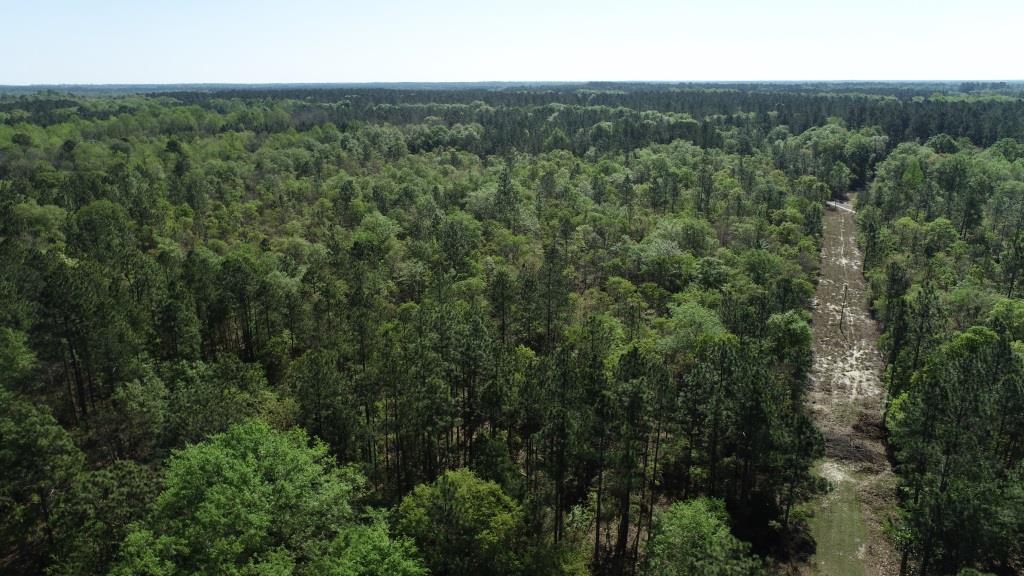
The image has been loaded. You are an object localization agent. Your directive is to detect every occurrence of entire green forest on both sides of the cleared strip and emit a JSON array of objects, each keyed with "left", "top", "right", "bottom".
[{"left": 0, "top": 83, "right": 1024, "bottom": 575}]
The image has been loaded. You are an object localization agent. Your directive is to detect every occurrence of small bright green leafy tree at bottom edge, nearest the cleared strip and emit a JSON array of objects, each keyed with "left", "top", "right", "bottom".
[{"left": 644, "top": 498, "right": 763, "bottom": 576}]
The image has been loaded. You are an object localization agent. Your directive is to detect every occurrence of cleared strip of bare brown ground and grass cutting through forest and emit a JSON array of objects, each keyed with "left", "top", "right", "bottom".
[{"left": 801, "top": 193, "right": 898, "bottom": 576}]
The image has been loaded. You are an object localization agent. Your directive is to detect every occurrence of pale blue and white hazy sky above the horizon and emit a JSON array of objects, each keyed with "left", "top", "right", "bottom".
[{"left": 0, "top": 0, "right": 1024, "bottom": 85}]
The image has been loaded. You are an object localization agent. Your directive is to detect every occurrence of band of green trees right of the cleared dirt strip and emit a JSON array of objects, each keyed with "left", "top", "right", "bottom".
[{"left": 860, "top": 134, "right": 1024, "bottom": 574}]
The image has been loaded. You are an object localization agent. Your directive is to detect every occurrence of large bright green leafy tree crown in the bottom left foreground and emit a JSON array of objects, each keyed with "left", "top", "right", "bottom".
[{"left": 112, "top": 421, "right": 428, "bottom": 576}]
